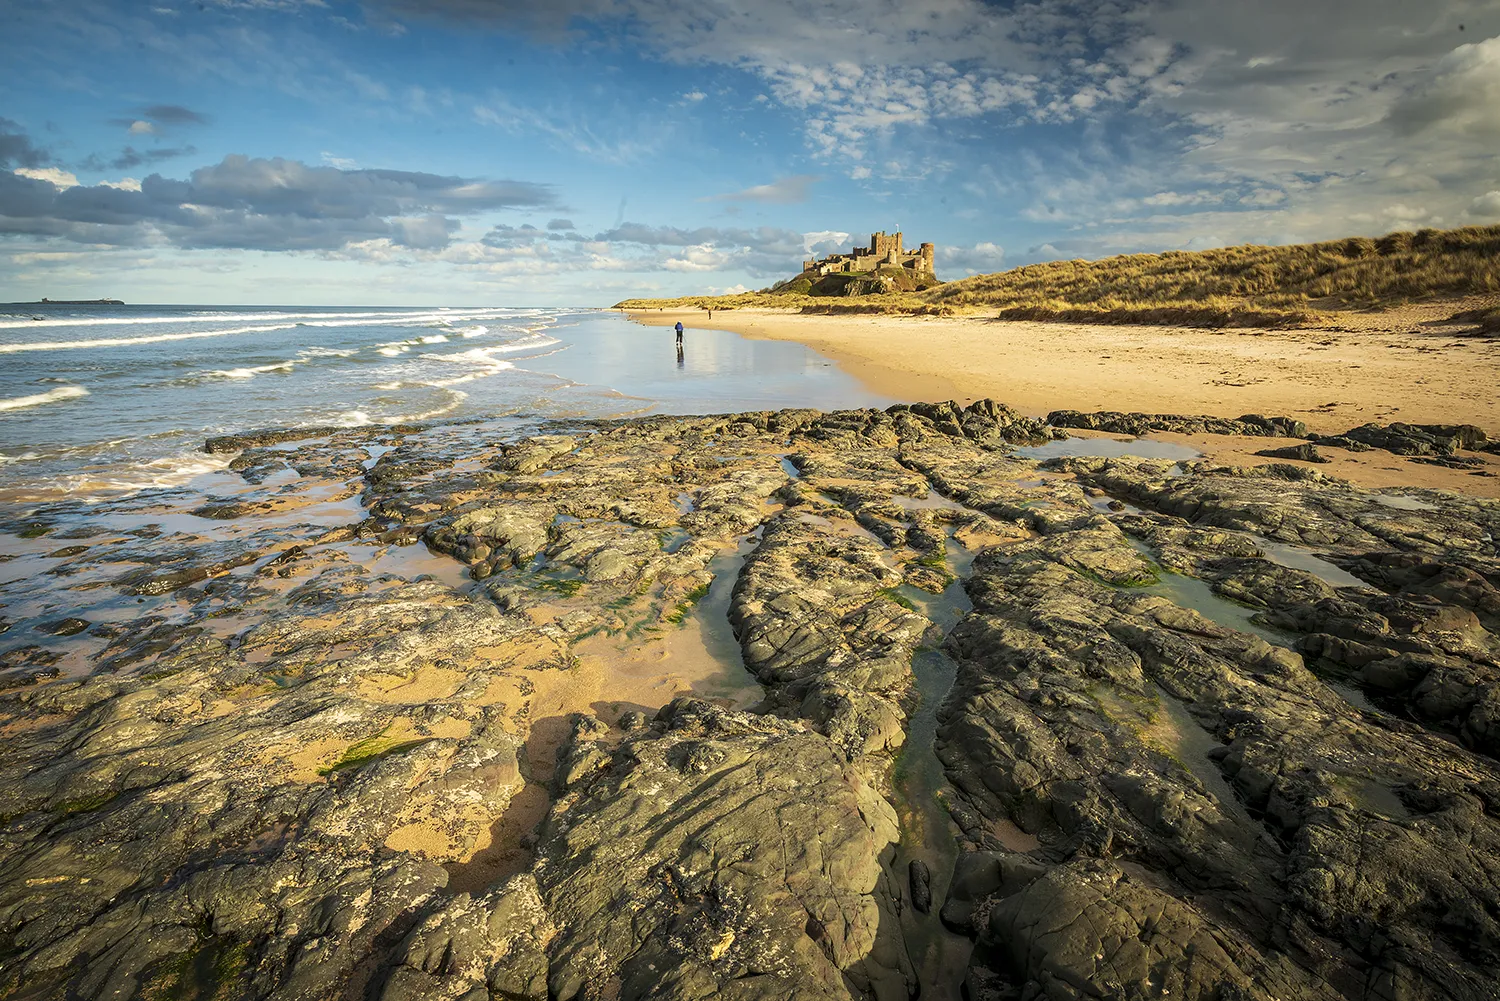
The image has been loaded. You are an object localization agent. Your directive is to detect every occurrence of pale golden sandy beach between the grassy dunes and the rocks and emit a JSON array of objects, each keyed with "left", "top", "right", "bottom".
[{"left": 629, "top": 305, "right": 1500, "bottom": 497}]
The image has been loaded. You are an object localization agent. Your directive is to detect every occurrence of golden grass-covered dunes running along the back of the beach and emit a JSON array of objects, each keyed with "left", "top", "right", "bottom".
[{"left": 620, "top": 227, "right": 1500, "bottom": 327}]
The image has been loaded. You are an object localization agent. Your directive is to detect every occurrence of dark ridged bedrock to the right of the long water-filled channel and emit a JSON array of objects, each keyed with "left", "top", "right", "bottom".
[{"left": 939, "top": 459, "right": 1500, "bottom": 998}]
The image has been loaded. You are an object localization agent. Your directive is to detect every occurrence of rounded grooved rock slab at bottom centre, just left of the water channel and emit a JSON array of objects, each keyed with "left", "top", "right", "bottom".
[{"left": 539, "top": 699, "right": 911, "bottom": 998}]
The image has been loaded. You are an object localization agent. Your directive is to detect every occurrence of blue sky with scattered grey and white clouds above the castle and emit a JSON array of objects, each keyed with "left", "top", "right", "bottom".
[{"left": 0, "top": 0, "right": 1500, "bottom": 306}]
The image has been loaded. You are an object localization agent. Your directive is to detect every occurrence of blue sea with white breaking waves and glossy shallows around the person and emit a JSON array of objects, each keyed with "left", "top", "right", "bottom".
[{"left": 0, "top": 305, "right": 893, "bottom": 503}]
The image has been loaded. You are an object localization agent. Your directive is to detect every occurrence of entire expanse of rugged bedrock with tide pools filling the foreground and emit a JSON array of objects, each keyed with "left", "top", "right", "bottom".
[{"left": 0, "top": 401, "right": 1500, "bottom": 1001}]
